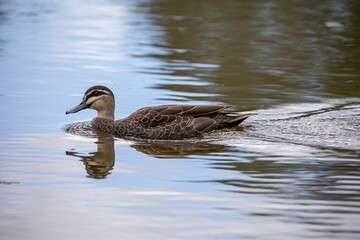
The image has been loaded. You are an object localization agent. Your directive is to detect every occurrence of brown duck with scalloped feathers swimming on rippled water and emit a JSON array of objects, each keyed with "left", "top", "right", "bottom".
[{"left": 66, "top": 85, "right": 253, "bottom": 140}]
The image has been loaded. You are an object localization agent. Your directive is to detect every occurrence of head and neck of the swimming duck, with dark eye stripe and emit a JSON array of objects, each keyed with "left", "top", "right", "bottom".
[{"left": 66, "top": 86, "right": 115, "bottom": 119}]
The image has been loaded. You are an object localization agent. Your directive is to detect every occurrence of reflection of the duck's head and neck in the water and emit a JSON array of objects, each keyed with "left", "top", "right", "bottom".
[{"left": 66, "top": 134, "right": 115, "bottom": 179}]
